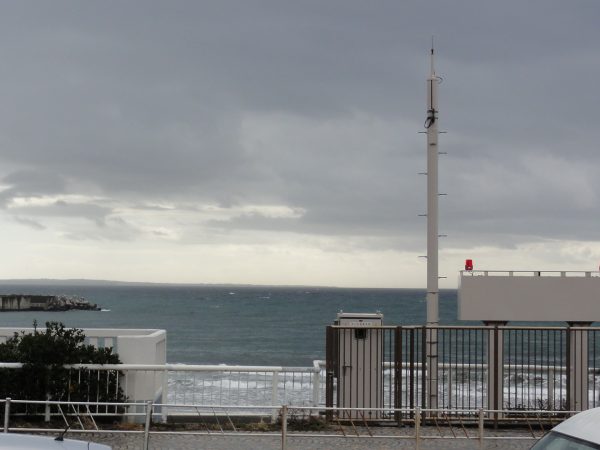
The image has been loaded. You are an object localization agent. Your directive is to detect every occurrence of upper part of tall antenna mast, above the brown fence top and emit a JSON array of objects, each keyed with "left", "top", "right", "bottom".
[{"left": 425, "top": 44, "right": 439, "bottom": 325}]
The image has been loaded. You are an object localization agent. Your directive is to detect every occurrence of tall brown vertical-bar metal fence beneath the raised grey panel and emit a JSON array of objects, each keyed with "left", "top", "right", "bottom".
[{"left": 326, "top": 326, "right": 600, "bottom": 419}]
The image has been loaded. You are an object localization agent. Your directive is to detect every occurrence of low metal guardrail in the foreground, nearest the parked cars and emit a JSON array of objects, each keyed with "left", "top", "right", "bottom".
[{"left": 0, "top": 399, "right": 575, "bottom": 450}]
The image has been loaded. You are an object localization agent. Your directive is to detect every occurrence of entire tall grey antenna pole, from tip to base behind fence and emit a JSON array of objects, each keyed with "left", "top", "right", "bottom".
[{"left": 425, "top": 46, "right": 439, "bottom": 409}]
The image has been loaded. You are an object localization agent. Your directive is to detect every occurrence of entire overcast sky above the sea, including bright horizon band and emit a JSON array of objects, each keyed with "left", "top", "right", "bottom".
[{"left": 0, "top": 0, "right": 600, "bottom": 287}]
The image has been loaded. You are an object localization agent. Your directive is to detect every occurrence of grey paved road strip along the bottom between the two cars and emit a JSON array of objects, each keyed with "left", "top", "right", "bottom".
[{"left": 59, "top": 429, "right": 534, "bottom": 450}]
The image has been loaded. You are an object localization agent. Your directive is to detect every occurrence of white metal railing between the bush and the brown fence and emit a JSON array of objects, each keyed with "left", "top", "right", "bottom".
[{"left": 0, "top": 361, "right": 325, "bottom": 420}]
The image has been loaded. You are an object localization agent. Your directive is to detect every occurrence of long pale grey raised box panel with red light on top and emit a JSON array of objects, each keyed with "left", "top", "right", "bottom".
[{"left": 458, "top": 272, "right": 600, "bottom": 322}]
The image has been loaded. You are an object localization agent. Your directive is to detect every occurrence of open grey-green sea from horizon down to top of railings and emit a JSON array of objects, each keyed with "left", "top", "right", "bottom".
[{"left": 0, "top": 285, "right": 458, "bottom": 366}]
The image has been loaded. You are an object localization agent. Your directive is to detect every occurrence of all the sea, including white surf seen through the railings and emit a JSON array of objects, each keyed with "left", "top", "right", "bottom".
[{"left": 0, "top": 285, "right": 600, "bottom": 407}]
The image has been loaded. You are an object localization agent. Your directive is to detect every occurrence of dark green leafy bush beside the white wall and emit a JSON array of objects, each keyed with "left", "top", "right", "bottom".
[{"left": 0, "top": 322, "right": 126, "bottom": 410}]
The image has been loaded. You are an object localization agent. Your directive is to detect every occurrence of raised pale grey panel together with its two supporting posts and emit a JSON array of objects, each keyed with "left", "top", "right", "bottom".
[{"left": 458, "top": 270, "right": 600, "bottom": 411}]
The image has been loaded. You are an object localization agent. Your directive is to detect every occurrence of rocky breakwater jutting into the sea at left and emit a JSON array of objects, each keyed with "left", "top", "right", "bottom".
[{"left": 0, "top": 294, "right": 100, "bottom": 311}]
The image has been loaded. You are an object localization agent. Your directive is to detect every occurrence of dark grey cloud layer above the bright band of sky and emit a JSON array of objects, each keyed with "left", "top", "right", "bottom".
[{"left": 0, "top": 0, "right": 600, "bottom": 250}]
